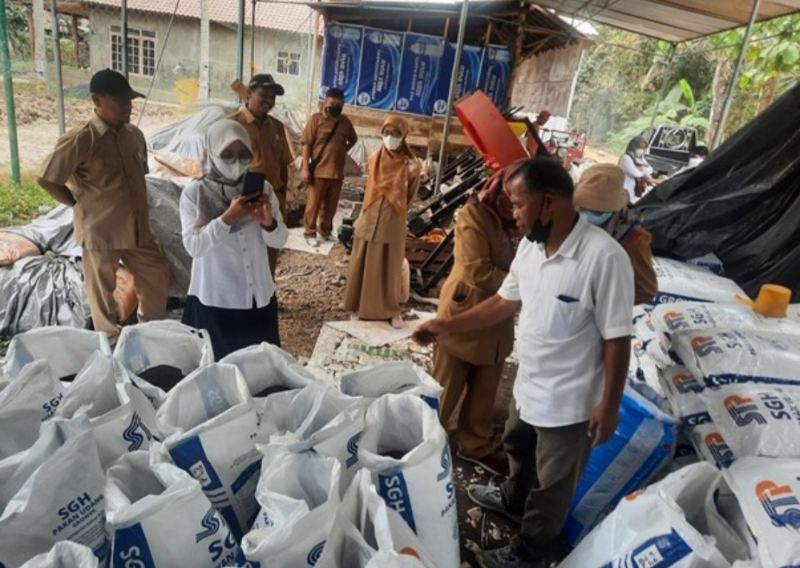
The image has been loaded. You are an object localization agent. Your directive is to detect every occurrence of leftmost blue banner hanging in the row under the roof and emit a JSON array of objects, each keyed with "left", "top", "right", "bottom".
[{"left": 319, "top": 24, "right": 364, "bottom": 104}]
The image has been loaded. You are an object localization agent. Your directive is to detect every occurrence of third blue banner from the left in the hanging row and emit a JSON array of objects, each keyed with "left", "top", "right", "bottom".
[{"left": 394, "top": 33, "right": 449, "bottom": 116}]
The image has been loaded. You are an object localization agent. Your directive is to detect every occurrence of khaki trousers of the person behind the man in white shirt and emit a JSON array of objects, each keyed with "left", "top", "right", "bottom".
[{"left": 433, "top": 348, "right": 503, "bottom": 458}]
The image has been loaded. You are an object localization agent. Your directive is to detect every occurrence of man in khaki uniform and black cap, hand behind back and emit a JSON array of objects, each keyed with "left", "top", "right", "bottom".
[{"left": 37, "top": 69, "right": 169, "bottom": 341}]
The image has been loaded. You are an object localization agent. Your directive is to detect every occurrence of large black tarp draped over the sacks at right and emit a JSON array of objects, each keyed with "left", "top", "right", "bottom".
[{"left": 637, "top": 85, "right": 800, "bottom": 302}]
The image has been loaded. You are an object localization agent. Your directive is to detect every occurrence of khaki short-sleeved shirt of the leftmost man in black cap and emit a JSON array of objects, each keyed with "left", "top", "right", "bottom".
[{"left": 41, "top": 115, "right": 153, "bottom": 250}]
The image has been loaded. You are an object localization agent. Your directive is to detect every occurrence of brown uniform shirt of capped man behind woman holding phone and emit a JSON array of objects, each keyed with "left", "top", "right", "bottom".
[{"left": 230, "top": 107, "right": 292, "bottom": 191}]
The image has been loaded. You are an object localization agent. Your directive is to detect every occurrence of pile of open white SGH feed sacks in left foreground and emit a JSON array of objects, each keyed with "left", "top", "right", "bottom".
[{"left": 0, "top": 321, "right": 460, "bottom": 568}]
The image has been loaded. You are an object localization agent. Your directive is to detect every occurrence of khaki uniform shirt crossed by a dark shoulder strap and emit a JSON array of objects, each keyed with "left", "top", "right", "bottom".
[{"left": 302, "top": 112, "right": 358, "bottom": 179}]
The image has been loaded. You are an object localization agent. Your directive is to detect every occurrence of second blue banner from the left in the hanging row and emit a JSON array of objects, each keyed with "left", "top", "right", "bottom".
[{"left": 356, "top": 28, "right": 403, "bottom": 110}]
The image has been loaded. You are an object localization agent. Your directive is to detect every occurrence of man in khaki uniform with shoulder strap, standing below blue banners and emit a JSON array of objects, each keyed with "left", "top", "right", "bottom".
[{"left": 303, "top": 89, "right": 358, "bottom": 241}]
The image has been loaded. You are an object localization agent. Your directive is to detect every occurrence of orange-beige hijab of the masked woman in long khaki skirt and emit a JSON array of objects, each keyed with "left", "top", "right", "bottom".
[{"left": 363, "top": 115, "right": 419, "bottom": 215}]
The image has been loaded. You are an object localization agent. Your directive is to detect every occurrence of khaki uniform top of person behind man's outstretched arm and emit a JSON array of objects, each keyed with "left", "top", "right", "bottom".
[{"left": 436, "top": 204, "right": 514, "bottom": 365}]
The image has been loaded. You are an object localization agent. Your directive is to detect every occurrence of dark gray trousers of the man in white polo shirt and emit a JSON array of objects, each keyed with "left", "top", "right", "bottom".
[{"left": 501, "top": 399, "right": 592, "bottom": 553}]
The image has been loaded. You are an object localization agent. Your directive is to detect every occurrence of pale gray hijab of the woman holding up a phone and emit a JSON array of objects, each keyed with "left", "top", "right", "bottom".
[{"left": 195, "top": 118, "right": 253, "bottom": 229}]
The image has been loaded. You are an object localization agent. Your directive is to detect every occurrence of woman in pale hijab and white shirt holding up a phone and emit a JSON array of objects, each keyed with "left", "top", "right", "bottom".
[{"left": 180, "top": 119, "right": 287, "bottom": 359}]
